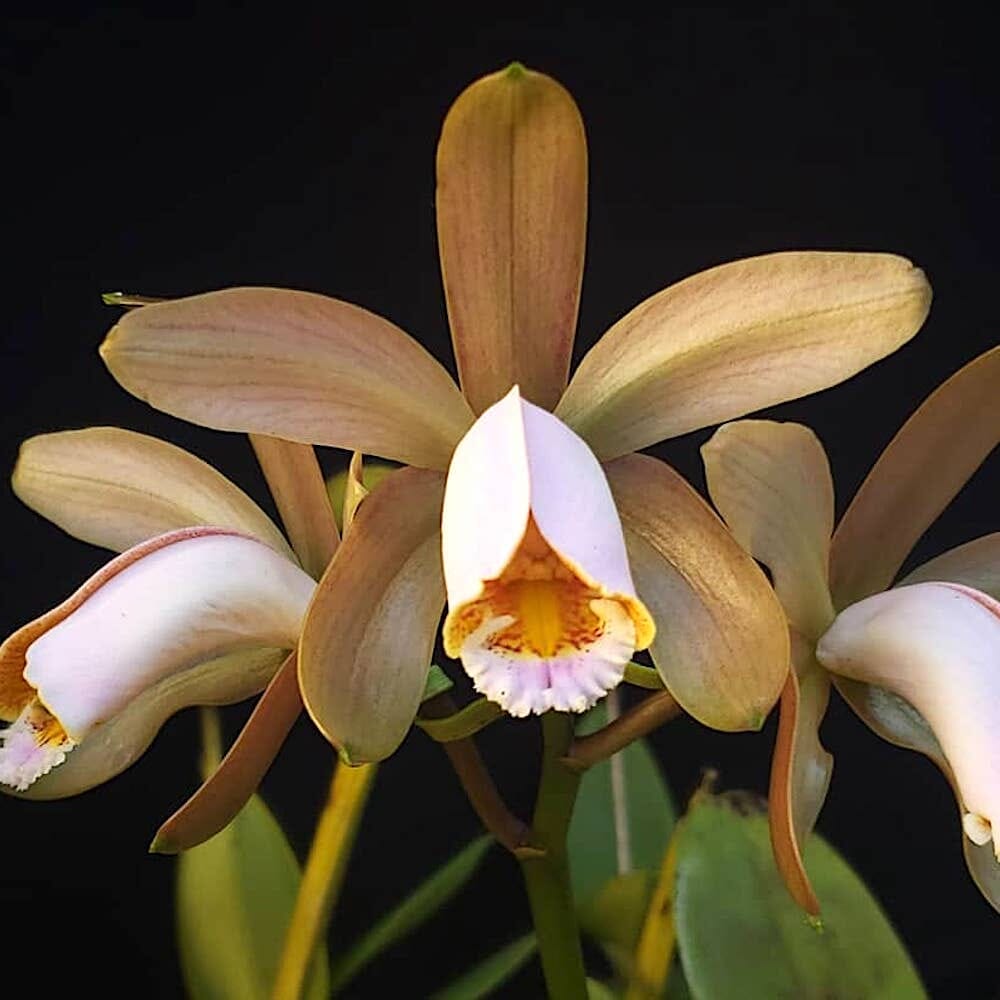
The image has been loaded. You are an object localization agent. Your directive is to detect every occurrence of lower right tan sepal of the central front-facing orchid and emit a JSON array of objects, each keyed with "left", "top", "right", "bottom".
[{"left": 605, "top": 455, "right": 789, "bottom": 730}]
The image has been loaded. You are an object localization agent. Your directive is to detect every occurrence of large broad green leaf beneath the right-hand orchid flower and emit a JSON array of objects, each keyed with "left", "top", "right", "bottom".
[{"left": 674, "top": 792, "right": 926, "bottom": 1000}]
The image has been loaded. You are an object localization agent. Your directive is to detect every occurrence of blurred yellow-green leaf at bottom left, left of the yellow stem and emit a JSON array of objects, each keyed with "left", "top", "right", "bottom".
[{"left": 177, "top": 795, "right": 329, "bottom": 1000}]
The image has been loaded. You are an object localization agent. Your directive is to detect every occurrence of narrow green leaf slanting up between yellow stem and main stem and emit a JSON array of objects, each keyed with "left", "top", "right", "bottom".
[{"left": 330, "top": 834, "right": 493, "bottom": 992}]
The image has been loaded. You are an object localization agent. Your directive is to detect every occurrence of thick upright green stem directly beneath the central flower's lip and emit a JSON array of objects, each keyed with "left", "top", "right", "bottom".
[{"left": 520, "top": 712, "right": 587, "bottom": 1000}]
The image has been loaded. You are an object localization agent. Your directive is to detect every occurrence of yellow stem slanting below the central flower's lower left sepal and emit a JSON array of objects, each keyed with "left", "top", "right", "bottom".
[{"left": 272, "top": 763, "right": 377, "bottom": 1000}]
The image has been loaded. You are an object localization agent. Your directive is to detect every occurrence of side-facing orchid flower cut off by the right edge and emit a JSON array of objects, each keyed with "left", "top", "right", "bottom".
[{"left": 702, "top": 348, "right": 1000, "bottom": 912}]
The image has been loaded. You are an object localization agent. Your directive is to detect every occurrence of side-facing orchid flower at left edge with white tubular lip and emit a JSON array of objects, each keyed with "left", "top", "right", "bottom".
[{"left": 0, "top": 427, "right": 322, "bottom": 816}]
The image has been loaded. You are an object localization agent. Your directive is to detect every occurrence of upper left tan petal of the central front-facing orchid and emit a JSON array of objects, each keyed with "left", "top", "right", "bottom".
[{"left": 101, "top": 288, "right": 472, "bottom": 469}]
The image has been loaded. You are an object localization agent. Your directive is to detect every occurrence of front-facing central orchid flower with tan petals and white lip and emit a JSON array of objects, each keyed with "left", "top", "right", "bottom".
[{"left": 92, "top": 65, "right": 930, "bottom": 763}]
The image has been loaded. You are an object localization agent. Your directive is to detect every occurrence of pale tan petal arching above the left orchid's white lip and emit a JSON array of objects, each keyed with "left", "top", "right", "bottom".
[{"left": 13, "top": 427, "right": 294, "bottom": 558}]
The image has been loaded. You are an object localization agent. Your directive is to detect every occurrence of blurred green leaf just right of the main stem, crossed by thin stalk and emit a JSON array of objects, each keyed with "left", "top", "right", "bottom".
[{"left": 568, "top": 700, "right": 676, "bottom": 907}]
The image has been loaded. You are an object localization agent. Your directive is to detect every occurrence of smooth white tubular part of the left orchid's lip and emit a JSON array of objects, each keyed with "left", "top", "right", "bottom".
[{"left": 10, "top": 529, "right": 315, "bottom": 742}]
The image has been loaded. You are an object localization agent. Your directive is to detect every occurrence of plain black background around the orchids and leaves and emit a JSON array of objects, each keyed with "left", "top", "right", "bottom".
[{"left": 0, "top": 4, "right": 1000, "bottom": 997}]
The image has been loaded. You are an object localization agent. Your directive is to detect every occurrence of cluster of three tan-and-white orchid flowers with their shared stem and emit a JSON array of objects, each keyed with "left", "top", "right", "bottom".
[{"left": 0, "top": 65, "right": 1000, "bottom": 997}]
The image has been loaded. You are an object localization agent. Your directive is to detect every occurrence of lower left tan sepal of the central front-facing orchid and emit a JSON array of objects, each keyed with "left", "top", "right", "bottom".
[{"left": 299, "top": 469, "right": 444, "bottom": 764}]
